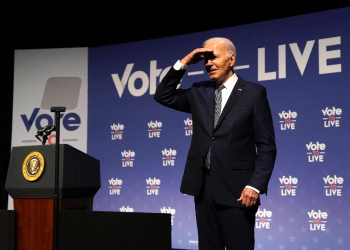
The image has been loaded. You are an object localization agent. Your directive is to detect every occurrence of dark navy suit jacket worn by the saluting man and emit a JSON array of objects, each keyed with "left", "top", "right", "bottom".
[{"left": 154, "top": 68, "right": 276, "bottom": 207}]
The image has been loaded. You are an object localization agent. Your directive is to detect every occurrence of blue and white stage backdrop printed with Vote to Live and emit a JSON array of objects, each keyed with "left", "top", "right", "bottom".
[{"left": 13, "top": 8, "right": 350, "bottom": 250}]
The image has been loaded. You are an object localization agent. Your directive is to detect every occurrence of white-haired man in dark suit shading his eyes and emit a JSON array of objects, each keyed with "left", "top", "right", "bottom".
[{"left": 154, "top": 38, "right": 276, "bottom": 250}]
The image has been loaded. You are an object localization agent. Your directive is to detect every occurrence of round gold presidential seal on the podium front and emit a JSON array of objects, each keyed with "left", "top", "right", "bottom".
[{"left": 22, "top": 151, "right": 45, "bottom": 181}]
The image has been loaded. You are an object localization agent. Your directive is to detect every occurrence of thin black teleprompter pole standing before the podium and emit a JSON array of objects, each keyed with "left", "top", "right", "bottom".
[{"left": 51, "top": 107, "right": 66, "bottom": 250}]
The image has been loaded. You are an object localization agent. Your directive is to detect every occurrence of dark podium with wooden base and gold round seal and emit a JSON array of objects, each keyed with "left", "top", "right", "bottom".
[{"left": 5, "top": 144, "right": 101, "bottom": 250}]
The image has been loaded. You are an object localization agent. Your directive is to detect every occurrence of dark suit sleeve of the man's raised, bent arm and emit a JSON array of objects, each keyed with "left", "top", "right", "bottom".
[{"left": 154, "top": 67, "right": 191, "bottom": 113}]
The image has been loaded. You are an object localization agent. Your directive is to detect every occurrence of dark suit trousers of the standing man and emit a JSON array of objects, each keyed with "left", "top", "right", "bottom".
[{"left": 195, "top": 168, "right": 258, "bottom": 250}]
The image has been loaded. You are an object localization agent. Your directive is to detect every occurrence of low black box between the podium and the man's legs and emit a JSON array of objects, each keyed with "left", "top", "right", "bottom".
[{"left": 58, "top": 210, "right": 171, "bottom": 250}]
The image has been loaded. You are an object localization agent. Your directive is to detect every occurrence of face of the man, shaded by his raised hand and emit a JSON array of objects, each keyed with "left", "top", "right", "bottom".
[{"left": 204, "top": 41, "right": 235, "bottom": 84}]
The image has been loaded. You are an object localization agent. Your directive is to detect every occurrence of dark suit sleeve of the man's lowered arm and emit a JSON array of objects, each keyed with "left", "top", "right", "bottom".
[{"left": 247, "top": 88, "right": 277, "bottom": 194}]
